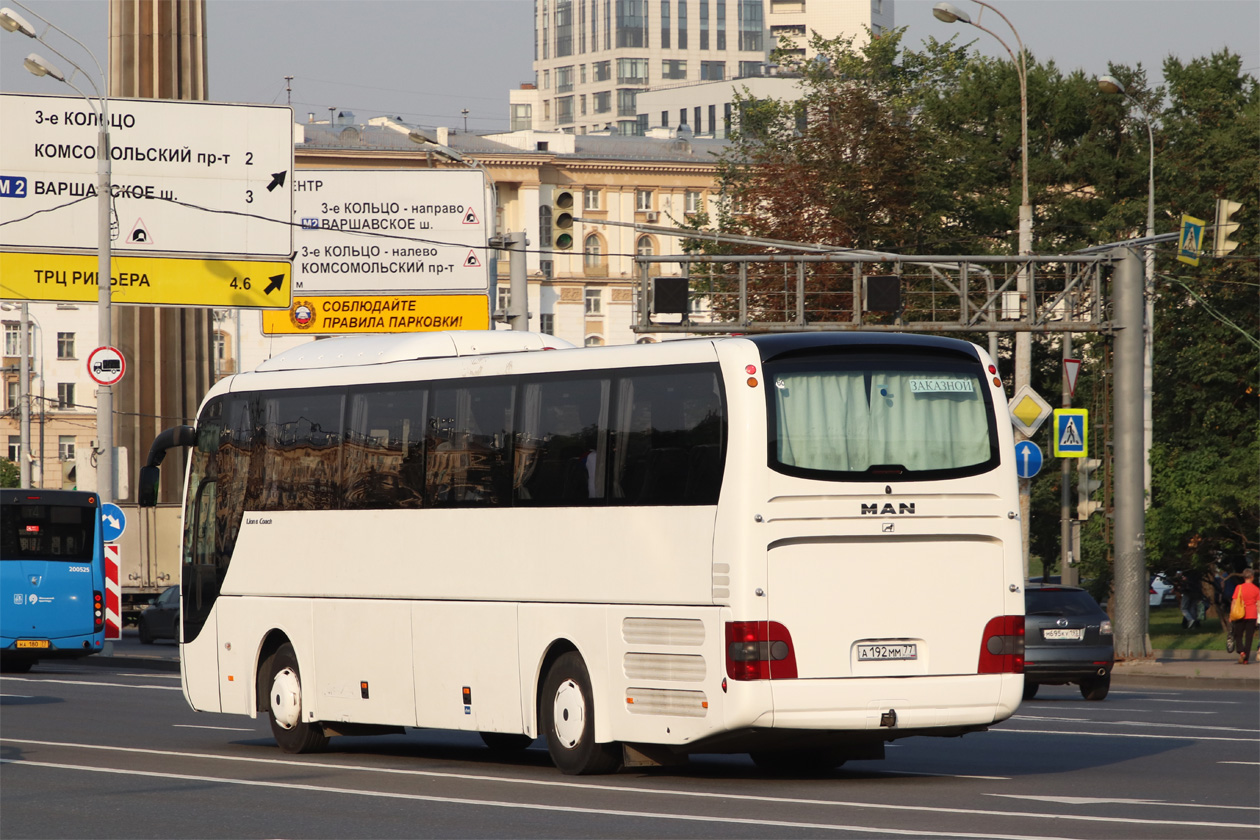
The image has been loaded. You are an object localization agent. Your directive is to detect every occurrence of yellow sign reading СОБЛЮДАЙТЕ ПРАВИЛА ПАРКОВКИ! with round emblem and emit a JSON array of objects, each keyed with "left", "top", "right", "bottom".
[{"left": 262, "top": 295, "right": 490, "bottom": 335}]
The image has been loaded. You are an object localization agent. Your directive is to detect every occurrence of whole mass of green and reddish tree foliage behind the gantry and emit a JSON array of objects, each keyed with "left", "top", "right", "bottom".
[{"left": 693, "top": 31, "right": 1260, "bottom": 587}]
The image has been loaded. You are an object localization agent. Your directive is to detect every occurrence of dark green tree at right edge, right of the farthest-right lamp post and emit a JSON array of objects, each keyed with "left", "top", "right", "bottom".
[{"left": 1147, "top": 50, "right": 1260, "bottom": 579}]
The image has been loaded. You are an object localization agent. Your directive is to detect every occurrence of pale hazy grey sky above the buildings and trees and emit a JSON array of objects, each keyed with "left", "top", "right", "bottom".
[{"left": 0, "top": 0, "right": 1260, "bottom": 132}]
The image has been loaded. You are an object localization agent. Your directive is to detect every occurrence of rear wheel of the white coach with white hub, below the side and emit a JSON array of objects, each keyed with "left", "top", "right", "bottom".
[{"left": 539, "top": 651, "right": 621, "bottom": 776}]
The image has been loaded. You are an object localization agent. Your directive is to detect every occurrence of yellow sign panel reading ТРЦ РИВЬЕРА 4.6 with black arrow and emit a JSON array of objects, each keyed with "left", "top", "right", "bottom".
[{"left": 0, "top": 253, "right": 292, "bottom": 309}]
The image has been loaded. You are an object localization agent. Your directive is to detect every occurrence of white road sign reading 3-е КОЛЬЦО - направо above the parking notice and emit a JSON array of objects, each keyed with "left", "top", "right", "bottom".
[{"left": 294, "top": 169, "right": 490, "bottom": 298}]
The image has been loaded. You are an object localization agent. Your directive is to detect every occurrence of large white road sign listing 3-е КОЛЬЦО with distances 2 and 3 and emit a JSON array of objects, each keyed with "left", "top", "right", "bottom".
[{"left": 0, "top": 93, "right": 294, "bottom": 258}]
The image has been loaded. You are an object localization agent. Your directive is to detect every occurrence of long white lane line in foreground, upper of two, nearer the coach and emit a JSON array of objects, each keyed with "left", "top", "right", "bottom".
[{"left": 0, "top": 729, "right": 1255, "bottom": 836}]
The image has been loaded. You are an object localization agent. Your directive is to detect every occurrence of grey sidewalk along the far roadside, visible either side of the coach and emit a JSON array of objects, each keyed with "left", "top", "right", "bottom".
[{"left": 78, "top": 645, "right": 1260, "bottom": 691}]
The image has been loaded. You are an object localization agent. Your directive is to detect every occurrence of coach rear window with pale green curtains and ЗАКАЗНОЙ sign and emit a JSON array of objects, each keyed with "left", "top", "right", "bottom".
[{"left": 766, "top": 354, "right": 999, "bottom": 481}]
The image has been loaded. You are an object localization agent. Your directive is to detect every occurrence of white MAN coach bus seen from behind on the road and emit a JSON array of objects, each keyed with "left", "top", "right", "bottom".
[{"left": 141, "top": 331, "right": 1023, "bottom": 773}]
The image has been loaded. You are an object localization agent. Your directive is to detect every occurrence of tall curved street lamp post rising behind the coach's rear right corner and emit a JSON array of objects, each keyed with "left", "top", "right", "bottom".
[{"left": 932, "top": 0, "right": 1033, "bottom": 577}]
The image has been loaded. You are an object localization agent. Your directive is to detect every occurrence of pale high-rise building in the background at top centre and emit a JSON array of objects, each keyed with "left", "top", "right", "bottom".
[{"left": 509, "top": 0, "right": 893, "bottom": 137}]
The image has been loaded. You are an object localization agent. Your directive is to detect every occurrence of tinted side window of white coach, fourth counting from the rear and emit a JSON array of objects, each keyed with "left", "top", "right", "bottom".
[{"left": 343, "top": 385, "right": 428, "bottom": 509}]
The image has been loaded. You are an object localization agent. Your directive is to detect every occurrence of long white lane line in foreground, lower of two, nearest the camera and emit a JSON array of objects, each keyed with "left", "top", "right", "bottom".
[{"left": 0, "top": 758, "right": 1083, "bottom": 840}]
